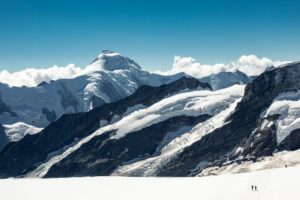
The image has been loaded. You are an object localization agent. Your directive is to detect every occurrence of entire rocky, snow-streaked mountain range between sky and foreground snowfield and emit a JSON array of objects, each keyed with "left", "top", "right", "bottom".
[{"left": 0, "top": 51, "right": 300, "bottom": 178}]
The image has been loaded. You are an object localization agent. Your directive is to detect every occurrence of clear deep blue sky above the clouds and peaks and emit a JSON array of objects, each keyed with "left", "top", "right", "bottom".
[{"left": 0, "top": 0, "right": 300, "bottom": 71}]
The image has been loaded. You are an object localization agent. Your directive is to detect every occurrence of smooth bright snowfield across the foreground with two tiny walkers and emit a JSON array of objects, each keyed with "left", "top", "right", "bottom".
[{"left": 0, "top": 166, "right": 300, "bottom": 200}]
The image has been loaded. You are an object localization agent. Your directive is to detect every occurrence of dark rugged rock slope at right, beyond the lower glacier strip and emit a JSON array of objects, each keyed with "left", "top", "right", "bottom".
[{"left": 159, "top": 63, "right": 300, "bottom": 176}]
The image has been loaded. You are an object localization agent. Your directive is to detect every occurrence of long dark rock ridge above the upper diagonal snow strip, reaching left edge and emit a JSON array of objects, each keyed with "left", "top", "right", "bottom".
[{"left": 0, "top": 77, "right": 210, "bottom": 178}]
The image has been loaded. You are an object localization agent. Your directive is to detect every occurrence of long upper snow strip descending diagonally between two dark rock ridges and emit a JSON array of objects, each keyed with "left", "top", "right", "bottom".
[{"left": 27, "top": 85, "right": 245, "bottom": 177}]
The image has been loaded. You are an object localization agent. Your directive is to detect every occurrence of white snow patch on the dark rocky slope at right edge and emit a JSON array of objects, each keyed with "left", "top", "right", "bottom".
[{"left": 264, "top": 91, "right": 300, "bottom": 144}]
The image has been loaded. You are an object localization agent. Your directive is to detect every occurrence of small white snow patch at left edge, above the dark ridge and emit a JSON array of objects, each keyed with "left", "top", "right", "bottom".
[{"left": 3, "top": 122, "right": 43, "bottom": 141}]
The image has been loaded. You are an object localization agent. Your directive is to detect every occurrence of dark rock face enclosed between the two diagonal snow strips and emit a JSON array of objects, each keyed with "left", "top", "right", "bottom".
[{"left": 45, "top": 115, "right": 210, "bottom": 177}]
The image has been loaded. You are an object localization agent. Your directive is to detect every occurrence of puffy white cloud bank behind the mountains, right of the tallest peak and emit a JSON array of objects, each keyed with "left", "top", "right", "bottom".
[{"left": 157, "top": 55, "right": 289, "bottom": 78}]
